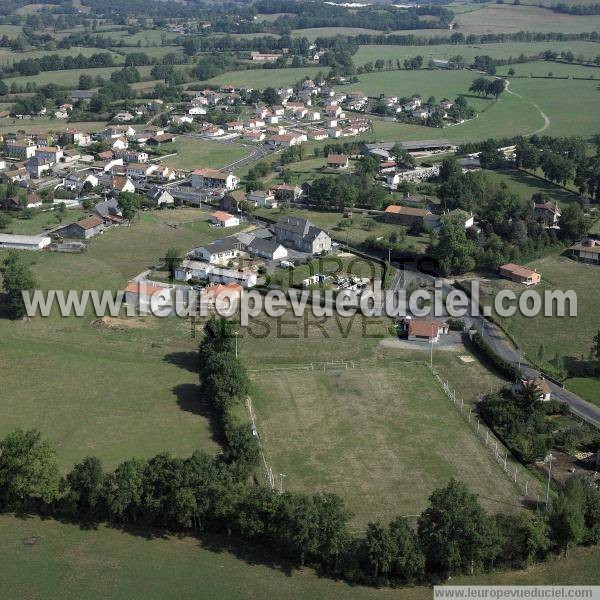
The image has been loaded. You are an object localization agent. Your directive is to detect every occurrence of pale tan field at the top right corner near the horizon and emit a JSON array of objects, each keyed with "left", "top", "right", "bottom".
[{"left": 454, "top": 4, "right": 600, "bottom": 35}]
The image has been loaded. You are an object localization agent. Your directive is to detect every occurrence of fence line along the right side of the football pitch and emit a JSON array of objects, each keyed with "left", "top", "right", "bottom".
[{"left": 431, "top": 368, "right": 541, "bottom": 505}]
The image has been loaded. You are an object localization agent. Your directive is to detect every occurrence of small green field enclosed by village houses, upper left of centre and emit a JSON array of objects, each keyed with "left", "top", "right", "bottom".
[{"left": 162, "top": 136, "right": 250, "bottom": 170}]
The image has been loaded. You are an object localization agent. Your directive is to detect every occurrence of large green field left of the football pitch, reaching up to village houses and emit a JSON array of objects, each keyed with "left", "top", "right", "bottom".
[{"left": 0, "top": 209, "right": 248, "bottom": 469}]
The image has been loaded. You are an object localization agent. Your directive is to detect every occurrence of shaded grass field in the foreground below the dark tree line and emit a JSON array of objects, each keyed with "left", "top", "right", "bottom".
[{"left": 0, "top": 515, "right": 599, "bottom": 600}]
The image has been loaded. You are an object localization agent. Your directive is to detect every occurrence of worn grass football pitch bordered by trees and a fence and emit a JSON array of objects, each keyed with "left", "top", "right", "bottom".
[{"left": 252, "top": 355, "right": 519, "bottom": 527}]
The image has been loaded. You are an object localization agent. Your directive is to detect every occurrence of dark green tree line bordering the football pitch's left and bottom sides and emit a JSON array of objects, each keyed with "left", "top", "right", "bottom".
[{"left": 0, "top": 319, "right": 600, "bottom": 584}]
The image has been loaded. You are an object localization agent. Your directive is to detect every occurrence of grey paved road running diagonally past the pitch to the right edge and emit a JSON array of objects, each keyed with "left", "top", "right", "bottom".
[{"left": 392, "top": 263, "right": 600, "bottom": 427}]
